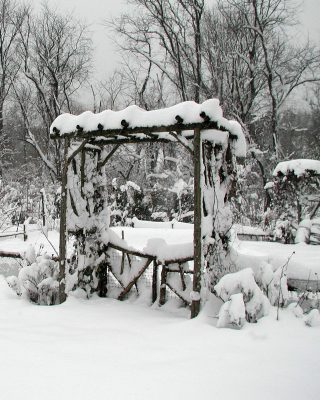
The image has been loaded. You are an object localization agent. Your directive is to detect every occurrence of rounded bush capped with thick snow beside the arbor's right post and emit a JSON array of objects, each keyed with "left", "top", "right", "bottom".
[{"left": 214, "top": 268, "right": 270, "bottom": 327}]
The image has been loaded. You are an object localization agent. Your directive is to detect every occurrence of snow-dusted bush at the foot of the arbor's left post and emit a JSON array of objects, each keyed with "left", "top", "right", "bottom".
[{"left": 7, "top": 255, "right": 59, "bottom": 305}]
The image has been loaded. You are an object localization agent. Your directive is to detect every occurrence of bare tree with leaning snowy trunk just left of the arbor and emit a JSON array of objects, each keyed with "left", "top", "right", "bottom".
[{"left": 15, "top": 4, "right": 92, "bottom": 178}]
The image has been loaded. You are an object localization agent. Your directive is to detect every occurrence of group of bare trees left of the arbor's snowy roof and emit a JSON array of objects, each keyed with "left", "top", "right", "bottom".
[{"left": 0, "top": 0, "right": 92, "bottom": 179}]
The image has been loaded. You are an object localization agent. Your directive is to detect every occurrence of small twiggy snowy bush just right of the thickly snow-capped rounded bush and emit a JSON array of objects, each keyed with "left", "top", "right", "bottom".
[{"left": 255, "top": 262, "right": 289, "bottom": 307}]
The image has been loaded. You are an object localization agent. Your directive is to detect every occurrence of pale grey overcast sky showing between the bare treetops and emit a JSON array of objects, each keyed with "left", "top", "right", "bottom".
[{"left": 37, "top": 0, "right": 320, "bottom": 79}]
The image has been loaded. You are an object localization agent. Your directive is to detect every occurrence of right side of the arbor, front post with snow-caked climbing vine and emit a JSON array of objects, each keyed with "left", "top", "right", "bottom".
[{"left": 191, "top": 130, "right": 235, "bottom": 317}]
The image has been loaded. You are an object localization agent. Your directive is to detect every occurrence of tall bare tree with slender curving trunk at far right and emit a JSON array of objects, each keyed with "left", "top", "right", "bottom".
[{"left": 225, "top": 0, "right": 320, "bottom": 159}]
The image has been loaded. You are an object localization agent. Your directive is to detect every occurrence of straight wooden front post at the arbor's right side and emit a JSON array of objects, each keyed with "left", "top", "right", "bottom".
[{"left": 191, "top": 128, "right": 202, "bottom": 318}]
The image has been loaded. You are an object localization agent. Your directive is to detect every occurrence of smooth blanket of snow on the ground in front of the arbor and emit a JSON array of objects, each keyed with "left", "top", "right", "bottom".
[{"left": 0, "top": 276, "right": 320, "bottom": 400}]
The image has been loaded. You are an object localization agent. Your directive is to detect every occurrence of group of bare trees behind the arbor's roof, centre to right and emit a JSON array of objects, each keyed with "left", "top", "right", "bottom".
[{"left": 105, "top": 0, "right": 320, "bottom": 222}]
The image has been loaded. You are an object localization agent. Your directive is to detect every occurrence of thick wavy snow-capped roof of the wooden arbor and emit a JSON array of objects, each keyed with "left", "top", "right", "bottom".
[{"left": 50, "top": 99, "right": 246, "bottom": 157}]
